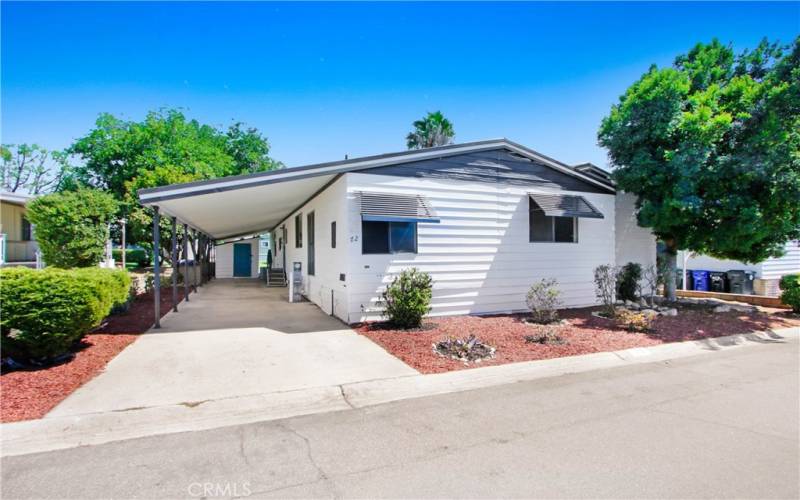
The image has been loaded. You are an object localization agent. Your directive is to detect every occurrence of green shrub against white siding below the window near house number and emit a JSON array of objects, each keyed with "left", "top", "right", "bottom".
[{"left": 382, "top": 267, "right": 433, "bottom": 328}]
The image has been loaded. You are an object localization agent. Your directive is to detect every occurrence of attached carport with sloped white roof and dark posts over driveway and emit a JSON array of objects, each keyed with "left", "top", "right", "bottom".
[{"left": 138, "top": 140, "right": 506, "bottom": 328}]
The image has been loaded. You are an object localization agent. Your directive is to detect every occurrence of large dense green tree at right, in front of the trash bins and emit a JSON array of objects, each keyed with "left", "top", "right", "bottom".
[{"left": 598, "top": 38, "right": 800, "bottom": 298}]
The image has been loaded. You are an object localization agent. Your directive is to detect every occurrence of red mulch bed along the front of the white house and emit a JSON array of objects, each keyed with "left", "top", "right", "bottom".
[{"left": 356, "top": 308, "right": 800, "bottom": 373}]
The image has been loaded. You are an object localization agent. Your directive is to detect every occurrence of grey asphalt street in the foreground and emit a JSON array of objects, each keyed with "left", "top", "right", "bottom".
[{"left": 2, "top": 338, "right": 800, "bottom": 499}]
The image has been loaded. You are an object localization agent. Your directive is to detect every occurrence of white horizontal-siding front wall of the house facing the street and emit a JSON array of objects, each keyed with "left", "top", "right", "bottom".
[{"left": 343, "top": 173, "right": 620, "bottom": 322}]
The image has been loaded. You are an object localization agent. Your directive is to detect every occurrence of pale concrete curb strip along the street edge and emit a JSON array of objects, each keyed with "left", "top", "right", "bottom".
[{"left": 0, "top": 327, "right": 800, "bottom": 456}]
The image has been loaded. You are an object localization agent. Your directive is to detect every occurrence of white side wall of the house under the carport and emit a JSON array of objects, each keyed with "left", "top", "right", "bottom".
[{"left": 274, "top": 177, "right": 349, "bottom": 321}]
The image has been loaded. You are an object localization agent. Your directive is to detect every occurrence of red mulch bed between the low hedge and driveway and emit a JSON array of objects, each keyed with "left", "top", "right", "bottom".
[{"left": 0, "top": 290, "right": 183, "bottom": 422}]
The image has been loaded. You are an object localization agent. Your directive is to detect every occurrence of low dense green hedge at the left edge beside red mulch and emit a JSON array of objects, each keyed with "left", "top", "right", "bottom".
[{"left": 0, "top": 267, "right": 131, "bottom": 360}]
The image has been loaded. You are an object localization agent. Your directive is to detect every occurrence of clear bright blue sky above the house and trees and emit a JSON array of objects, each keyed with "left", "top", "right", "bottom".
[{"left": 0, "top": 1, "right": 800, "bottom": 170}]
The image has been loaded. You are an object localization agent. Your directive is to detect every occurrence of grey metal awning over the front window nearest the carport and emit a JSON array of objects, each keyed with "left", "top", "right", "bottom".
[{"left": 358, "top": 191, "right": 439, "bottom": 222}]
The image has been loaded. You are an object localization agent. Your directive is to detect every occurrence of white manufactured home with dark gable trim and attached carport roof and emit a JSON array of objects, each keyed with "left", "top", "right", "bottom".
[{"left": 140, "top": 139, "right": 656, "bottom": 323}]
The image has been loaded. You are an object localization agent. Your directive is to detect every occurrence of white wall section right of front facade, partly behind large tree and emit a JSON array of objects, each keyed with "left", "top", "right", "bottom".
[{"left": 615, "top": 192, "right": 656, "bottom": 268}]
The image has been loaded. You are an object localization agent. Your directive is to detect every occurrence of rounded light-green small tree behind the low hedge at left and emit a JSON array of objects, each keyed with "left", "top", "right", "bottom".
[{"left": 27, "top": 189, "right": 117, "bottom": 268}]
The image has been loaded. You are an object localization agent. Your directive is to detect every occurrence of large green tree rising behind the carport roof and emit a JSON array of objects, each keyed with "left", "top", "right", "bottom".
[{"left": 68, "top": 109, "right": 282, "bottom": 255}]
